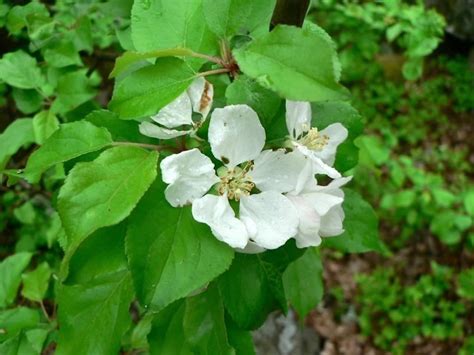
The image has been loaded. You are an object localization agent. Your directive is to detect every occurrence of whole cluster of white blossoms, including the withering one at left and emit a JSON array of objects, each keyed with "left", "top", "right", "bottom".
[{"left": 144, "top": 78, "right": 350, "bottom": 253}]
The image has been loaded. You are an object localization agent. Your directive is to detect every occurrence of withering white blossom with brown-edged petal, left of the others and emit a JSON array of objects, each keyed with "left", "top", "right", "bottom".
[{"left": 139, "top": 77, "right": 214, "bottom": 139}]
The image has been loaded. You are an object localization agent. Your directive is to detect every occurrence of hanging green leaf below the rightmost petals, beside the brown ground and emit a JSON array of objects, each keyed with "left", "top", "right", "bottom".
[{"left": 283, "top": 248, "right": 324, "bottom": 321}]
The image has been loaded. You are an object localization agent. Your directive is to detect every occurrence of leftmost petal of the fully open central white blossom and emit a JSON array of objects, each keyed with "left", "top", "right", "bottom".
[{"left": 160, "top": 149, "right": 219, "bottom": 207}]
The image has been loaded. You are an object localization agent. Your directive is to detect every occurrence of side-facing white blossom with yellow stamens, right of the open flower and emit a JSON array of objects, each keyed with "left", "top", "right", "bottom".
[{"left": 286, "top": 100, "right": 348, "bottom": 178}]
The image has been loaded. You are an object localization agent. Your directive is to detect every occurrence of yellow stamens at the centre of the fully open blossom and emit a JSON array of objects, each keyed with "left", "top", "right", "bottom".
[{"left": 217, "top": 163, "right": 255, "bottom": 201}]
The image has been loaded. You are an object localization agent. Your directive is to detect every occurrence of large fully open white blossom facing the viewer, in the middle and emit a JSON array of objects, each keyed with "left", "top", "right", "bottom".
[{"left": 161, "top": 105, "right": 304, "bottom": 252}]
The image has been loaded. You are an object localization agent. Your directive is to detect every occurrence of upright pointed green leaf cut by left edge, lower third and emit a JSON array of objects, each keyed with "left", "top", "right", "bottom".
[{"left": 0, "top": 253, "right": 31, "bottom": 309}]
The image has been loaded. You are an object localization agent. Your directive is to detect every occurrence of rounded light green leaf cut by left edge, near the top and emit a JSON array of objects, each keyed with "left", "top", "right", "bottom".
[{"left": 0, "top": 50, "right": 44, "bottom": 89}]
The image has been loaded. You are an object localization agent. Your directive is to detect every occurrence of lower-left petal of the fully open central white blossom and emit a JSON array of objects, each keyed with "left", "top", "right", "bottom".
[{"left": 192, "top": 195, "right": 249, "bottom": 249}]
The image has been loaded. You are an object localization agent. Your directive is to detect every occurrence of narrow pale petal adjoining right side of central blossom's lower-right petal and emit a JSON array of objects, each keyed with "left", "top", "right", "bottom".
[{"left": 287, "top": 196, "right": 321, "bottom": 248}]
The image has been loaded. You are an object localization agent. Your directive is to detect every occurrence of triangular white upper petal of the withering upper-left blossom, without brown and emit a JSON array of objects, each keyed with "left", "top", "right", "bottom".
[{"left": 151, "top": 91, "right": 193, "bottom": 128}]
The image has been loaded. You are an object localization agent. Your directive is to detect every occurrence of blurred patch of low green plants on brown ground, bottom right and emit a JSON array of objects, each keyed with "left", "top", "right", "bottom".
[{"left": 357, "top": 263, "right": 466, "bottom": 354}]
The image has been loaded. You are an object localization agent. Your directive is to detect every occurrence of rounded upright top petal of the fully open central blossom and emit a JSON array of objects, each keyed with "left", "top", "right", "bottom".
[{"left": 209, "top": 105, "right": 265, "bottom": 168}]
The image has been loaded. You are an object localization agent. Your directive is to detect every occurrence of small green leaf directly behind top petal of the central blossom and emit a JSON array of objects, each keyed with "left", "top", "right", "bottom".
[{"left": 225, "top": 75, "right": 281, "bottom": 128}]
